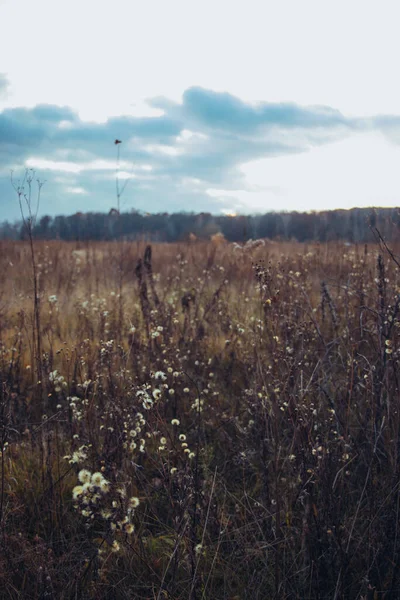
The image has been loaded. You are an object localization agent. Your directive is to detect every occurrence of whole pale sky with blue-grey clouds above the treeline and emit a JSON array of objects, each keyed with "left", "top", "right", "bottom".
[{"left": 0, "top": 0, "right": 400, "bottom": 220}]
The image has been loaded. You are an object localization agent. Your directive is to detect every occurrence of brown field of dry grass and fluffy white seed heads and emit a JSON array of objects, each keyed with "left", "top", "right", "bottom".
[{"left": 0, "top": 240, "right": 400, "bottom": 600}]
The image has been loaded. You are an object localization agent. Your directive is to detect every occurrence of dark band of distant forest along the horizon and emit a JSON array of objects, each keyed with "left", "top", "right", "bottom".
[{"left": 0, "top": 208, "right": 400, "bottom": 243}]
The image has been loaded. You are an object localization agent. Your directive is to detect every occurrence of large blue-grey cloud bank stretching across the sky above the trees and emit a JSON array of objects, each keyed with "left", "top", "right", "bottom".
[{"left": 0, "top": 86, "right": 400, "bottom": 218}]
